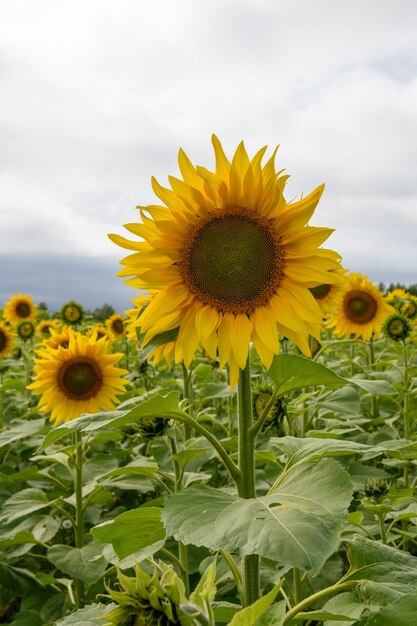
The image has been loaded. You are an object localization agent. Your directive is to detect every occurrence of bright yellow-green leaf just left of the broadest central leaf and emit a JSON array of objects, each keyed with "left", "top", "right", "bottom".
[{"left": 92, "top": 507, "right": 165, "bottom": 559}]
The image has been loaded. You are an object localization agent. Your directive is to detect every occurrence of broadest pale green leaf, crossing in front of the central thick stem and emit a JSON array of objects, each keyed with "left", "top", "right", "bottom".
[{"left": 162, "top": 459, "right": 352, "bottom": 574}]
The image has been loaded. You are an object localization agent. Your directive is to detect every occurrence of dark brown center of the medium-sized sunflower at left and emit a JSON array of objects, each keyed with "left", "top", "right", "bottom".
[{"left": 58, "top": 357, "right": 103, "bottom": 400}]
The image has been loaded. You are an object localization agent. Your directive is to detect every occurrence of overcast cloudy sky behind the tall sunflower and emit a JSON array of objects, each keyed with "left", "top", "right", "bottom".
[{"left": 0, "top": 0, "right": 417, "bottom": 311}]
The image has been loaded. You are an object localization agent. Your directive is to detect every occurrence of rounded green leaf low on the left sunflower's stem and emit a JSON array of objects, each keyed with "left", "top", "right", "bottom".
[{"left": 48, "top": 543, "right": 107, "bottom": 584}]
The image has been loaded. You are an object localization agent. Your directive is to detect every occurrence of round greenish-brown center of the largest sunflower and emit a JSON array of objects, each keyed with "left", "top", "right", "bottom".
[{"left": 179, "top": 206, "right": 284, "bottom": 314}]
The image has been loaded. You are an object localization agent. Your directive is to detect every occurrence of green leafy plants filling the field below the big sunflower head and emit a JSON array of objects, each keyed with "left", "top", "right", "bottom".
[{"left": 0, "top": 288, "right": 417, "bottom": 626}]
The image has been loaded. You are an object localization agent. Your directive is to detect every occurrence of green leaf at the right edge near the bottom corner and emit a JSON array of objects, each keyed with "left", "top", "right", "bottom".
[{"left": 344, "top": 535, "right": 417, "bottom": 604}]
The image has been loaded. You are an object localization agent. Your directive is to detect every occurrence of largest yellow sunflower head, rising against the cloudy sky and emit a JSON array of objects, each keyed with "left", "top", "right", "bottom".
[{"left": 110, "top": 136, "right": 343, "bottom": 384}]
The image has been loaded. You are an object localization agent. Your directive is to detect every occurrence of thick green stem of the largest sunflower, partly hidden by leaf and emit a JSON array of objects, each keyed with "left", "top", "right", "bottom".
[{"left": 237, "top": 357, "right": 260, "bottom": 607}]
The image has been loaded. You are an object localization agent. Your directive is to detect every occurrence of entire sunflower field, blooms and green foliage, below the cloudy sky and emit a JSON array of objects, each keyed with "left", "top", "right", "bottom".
[{"left": 0, "top": 137, "right": 417, "bottom": 626}]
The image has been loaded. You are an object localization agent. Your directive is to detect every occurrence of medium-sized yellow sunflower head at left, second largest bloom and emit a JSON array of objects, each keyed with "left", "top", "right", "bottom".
[{"left": 28, "top": 331, "right": 128, "bottom": 426}]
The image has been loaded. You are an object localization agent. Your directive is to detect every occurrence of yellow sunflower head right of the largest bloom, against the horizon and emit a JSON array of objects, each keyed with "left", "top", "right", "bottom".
[{"left": 328, "top": 272, "right": 394, "bottom": 340}]
